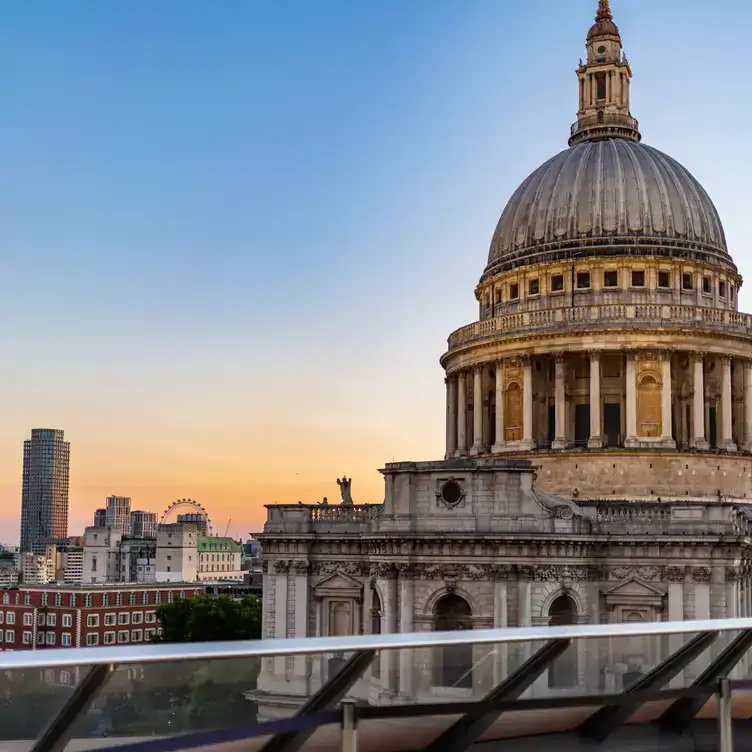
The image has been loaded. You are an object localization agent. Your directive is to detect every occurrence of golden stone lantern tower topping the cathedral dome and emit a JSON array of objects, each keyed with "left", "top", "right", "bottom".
[{"left": 569, "top": 0, "right": 641, "bottom": 146}]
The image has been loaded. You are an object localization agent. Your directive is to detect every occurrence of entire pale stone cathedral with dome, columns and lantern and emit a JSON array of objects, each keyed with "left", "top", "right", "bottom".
[{"left": 258, "top": 0, "right": 752, "bottom": 715}]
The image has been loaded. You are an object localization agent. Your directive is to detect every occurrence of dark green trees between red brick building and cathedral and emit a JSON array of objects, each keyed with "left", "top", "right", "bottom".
[{"left": 155, "top": 595, "right": 261, "bottom": 642}]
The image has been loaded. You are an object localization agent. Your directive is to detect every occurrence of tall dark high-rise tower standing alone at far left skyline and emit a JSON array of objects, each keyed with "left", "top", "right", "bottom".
[{"left": 21, "top": 428, "right": 70, "bottom": 554}]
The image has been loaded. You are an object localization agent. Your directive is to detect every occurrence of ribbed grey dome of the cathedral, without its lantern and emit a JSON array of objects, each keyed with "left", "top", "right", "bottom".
[{"left": 486, "top": 138, "right": 735, "bottom": 273}]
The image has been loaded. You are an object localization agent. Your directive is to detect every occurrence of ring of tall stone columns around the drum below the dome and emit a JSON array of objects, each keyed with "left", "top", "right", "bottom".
[{"left": 446, "top": 350, "right": 752, "bottom": 458}]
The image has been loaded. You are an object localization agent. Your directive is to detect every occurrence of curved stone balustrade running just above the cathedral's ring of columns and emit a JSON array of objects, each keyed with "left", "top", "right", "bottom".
[{"left": 448, "top": 304, "right": 752, "bottom": 351}]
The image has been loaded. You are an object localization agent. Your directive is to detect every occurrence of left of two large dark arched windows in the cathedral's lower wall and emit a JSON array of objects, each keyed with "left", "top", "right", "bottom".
[{"left": 433, "top": 593, "right": 473, "bottom": 689}]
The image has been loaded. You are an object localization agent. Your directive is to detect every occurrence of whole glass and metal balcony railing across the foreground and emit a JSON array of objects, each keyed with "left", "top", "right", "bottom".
[{"left": 0, "top": 618, "right": 752, "bottom": 752}]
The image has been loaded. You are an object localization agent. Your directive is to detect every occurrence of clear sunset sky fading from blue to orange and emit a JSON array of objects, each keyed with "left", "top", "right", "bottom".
[{"left": 0, "top": 0, "right": 752, "bottom": 542}]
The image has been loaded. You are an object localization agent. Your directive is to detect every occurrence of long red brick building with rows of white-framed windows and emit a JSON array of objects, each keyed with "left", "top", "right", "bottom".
[{"left": 0, "top": 582, "right": 204, "bottom": 650}]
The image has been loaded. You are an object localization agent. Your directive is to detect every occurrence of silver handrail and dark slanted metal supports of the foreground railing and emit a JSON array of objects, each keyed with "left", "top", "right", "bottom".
[{"left": 0, "top": 618, "right": 752, "bottom": 752}]
